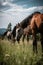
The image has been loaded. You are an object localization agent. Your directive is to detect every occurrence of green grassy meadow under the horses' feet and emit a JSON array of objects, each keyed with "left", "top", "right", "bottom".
[{"left": 0, "top": 39, "right": 43, "bottom": 65}]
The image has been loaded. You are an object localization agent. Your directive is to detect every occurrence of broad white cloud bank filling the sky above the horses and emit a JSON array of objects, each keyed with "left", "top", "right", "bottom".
[{"left": 0, "top": 2, "right": 43, "bottom": 28}]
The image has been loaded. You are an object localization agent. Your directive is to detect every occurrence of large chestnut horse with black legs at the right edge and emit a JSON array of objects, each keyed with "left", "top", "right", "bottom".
[{"left": 30, "top": 13, "right": 43, "bottom": 53}]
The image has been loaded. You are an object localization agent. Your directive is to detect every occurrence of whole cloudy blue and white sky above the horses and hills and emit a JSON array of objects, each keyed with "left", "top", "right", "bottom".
[{"left": 0, "top": 0, "right": 43, "bottom": 28}]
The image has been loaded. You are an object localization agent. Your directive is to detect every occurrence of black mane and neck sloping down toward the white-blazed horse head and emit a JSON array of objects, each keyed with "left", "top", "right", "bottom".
[{"left": 20, "top": 11, "right": 41, "bottom": 28}]
